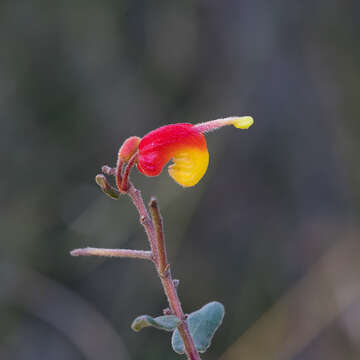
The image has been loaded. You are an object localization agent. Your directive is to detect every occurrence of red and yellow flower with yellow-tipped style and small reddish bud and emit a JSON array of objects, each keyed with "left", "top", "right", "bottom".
[{"left": 119, "top": 116, "right": 254, "bottom": 187}]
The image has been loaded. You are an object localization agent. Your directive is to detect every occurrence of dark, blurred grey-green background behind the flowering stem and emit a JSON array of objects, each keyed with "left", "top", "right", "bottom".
[{"left": 0, "top": 0, "right": 360, "bottom": 360}]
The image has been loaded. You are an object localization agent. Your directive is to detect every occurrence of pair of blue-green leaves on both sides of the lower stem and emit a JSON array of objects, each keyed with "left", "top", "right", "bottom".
[{"left": 131, "top": 301, "right": 225, "bottom": 354}]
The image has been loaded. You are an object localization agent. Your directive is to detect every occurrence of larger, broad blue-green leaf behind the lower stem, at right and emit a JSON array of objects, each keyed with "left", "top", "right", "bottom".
[{"left": 171, "top": 301, "right": 225, "bottom": 354}]
